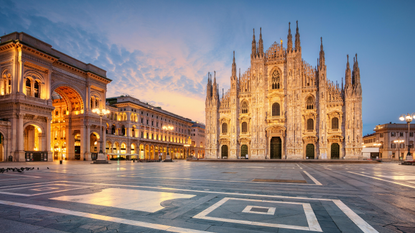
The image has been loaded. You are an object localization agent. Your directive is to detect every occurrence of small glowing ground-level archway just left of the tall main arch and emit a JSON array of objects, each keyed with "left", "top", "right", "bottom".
[{"left": 23, "top": 124, "right": 48, "bottom": 161}]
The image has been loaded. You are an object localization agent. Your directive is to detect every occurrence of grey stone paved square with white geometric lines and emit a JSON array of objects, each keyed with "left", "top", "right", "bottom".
[{"left": 0, "top": 161, "right": 415, "bottom": 233}]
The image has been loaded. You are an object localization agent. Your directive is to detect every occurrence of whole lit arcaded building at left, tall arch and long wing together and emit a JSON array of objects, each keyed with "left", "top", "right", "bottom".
[{"left": 0, "top": 32, "right": 197, "bottom": 161}]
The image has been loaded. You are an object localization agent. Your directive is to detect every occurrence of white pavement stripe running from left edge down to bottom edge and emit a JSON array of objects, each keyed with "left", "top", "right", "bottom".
[{"left": 0, "top": 200, "right": 211, "bottom": 232}]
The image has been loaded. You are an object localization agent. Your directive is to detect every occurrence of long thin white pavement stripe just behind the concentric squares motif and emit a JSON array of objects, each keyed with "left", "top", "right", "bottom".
[{"left": 60, "top": 180, "right": 333, "bottom": 201}]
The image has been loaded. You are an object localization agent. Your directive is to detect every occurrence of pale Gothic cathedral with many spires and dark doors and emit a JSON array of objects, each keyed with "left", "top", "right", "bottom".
[{"left": 205, "top": 22, "right": 363, "bottom": 159}]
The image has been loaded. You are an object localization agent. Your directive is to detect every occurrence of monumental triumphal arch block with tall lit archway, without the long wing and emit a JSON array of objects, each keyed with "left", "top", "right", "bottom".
[{"left": 0, "top": 32, "right": 111, "bottom": 161}]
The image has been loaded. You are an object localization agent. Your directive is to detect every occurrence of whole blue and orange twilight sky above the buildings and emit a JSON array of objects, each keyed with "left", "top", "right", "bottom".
[{"left": 0, "top": 0, "right": 415, "bottom": 134}]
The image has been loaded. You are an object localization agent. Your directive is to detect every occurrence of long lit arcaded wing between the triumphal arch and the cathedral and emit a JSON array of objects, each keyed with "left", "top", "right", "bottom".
[{"left": 105, "top": 96, "right": 192, "bottom": 160}]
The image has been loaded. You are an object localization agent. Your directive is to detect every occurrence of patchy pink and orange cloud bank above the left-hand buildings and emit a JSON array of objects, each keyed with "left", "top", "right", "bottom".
[{"left": 0, "top": 1, "right": 234, "bottom": 122}]
